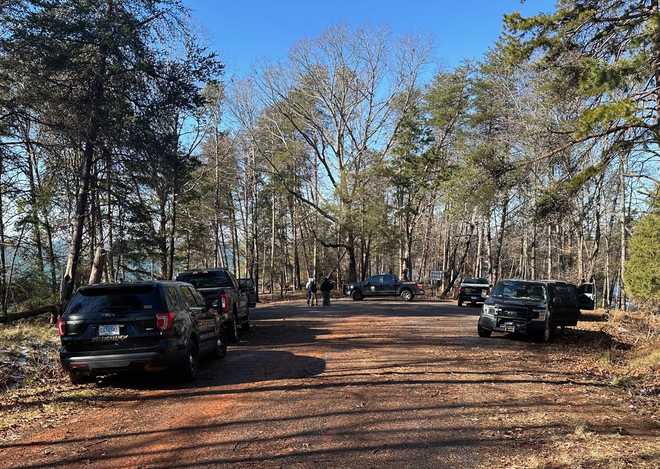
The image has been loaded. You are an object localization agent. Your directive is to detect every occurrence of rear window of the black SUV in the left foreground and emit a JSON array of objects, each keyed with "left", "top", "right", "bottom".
[{"left": 66, "top": 285, "right": 162, "bottom": 317}]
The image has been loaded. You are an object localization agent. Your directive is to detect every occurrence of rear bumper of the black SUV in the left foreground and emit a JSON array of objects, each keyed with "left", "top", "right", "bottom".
[{"left": 60, "top": 340, "right": 182, "bottom": 374}]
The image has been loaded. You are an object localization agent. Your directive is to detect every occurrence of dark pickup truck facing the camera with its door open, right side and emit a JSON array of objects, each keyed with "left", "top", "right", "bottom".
[{"left": 477, "top": 280, "right": 594, "bottom": 342}]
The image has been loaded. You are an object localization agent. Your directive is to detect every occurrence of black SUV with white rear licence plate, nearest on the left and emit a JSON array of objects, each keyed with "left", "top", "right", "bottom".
[{"left": 57, "top": 281, "right": 227, "bottom": 384}]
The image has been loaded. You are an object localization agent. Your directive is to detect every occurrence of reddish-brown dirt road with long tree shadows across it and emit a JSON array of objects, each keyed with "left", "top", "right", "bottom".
[{"left": 0, "top": 301, "right": 660, "bottom": 468}]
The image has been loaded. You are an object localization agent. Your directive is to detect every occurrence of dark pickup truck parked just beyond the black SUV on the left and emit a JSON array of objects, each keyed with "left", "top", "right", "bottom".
[{"left": 176, "top": 268, "right": 250, "bottom": 343}]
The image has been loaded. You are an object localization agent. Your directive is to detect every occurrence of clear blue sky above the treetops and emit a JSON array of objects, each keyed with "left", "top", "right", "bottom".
[{"left": 184, "top": 0, "right": 554, "bottom": 77}]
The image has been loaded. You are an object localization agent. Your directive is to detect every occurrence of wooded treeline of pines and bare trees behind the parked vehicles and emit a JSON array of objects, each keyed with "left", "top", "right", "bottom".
[{"left": 0, "top": 0, "right": 660, "bottom": 318}]
